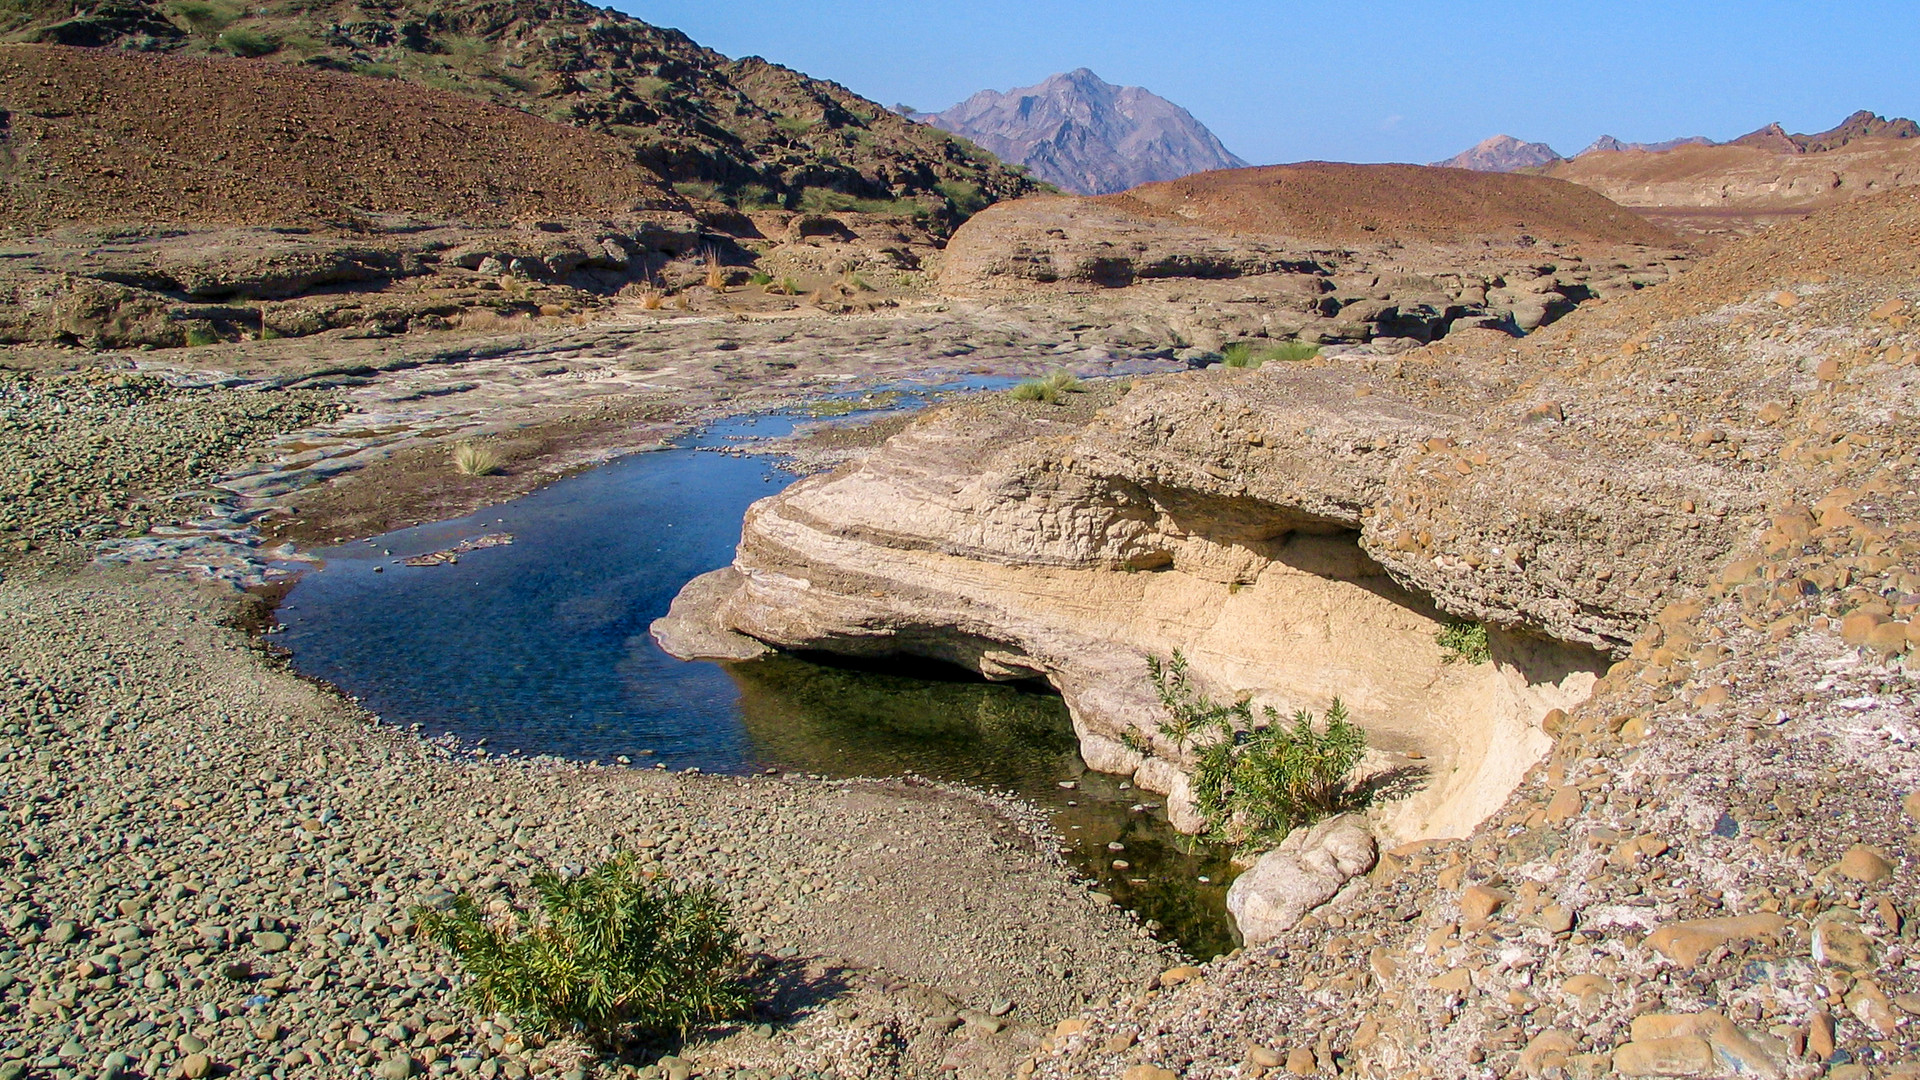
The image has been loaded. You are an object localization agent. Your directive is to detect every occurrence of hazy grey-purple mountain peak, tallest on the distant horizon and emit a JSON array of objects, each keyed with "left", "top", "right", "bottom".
[{"left": 916, "top": 67, "right": 1246, "bottom": 194}]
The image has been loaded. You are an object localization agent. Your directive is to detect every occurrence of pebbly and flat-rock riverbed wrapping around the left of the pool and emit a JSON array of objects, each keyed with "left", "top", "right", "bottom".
[{"left": 0, "top": 299, "right": 1221, "bottom": 1080}]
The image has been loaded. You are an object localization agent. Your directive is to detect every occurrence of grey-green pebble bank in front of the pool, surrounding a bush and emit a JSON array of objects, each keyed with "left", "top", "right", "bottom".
[{"left": 0, "top": 571, "right": 1173, "bottom": 1078}]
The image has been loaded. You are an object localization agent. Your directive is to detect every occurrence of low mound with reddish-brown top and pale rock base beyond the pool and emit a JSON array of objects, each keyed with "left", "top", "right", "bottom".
[{"left": 939, "top": 163, "right": 1686, "bottom": 350}]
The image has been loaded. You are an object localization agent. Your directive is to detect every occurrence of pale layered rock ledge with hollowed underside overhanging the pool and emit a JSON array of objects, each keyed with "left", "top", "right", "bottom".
[{"left": 657, "top": 342, "right": 1753, "bottom": 840}]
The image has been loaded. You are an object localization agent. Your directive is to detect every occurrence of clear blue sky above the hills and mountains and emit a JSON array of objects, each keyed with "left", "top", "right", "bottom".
[{"left": 614, "top": 0, "right": 1920, "bottom": 163}]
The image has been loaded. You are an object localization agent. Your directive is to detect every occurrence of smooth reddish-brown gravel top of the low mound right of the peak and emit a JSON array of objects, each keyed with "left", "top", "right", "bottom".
[{"left": 1104, "top": 161, "right": 1674, "bottom": 246}]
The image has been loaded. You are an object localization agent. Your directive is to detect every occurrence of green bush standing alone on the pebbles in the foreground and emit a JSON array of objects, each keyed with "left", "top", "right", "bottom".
[{"left": 413, "top": 853, "right": 751, "bottom": 1045}]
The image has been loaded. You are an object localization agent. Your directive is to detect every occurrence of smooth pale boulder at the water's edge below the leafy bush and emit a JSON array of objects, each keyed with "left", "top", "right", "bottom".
[{"left": 1227, "top": 815, "right": 1375, "bottom": 945}]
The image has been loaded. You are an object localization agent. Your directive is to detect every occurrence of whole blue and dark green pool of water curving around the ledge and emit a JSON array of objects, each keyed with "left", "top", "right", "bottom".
[{"left": 275, "top": 388, "right": 1233, "bottom": 957}]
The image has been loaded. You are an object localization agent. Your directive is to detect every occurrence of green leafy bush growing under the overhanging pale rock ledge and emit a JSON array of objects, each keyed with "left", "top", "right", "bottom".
[{"left": 1148, "top": 651, "right": 1371, "bottom": 847}]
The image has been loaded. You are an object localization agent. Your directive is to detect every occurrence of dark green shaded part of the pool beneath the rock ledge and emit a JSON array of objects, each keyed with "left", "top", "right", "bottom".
[{"left": 728, "top": 655, "right": 1235, "bottom": 959}]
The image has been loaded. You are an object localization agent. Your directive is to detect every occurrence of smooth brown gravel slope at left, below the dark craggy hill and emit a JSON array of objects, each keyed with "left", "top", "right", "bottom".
[{"left": 0, "top": 46, "right": 676, "bottom": 231}]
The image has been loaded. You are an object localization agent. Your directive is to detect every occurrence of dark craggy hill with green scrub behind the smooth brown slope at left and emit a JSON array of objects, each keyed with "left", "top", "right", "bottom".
[{"left": 10, "top": 0, "right": 1035, "bottom": 221}]
